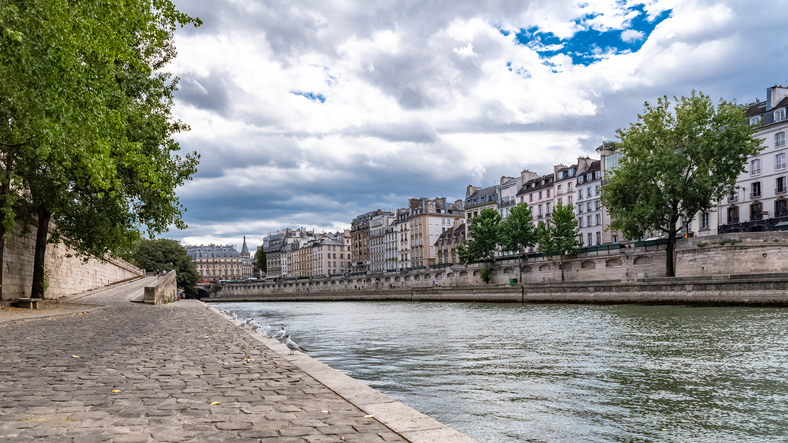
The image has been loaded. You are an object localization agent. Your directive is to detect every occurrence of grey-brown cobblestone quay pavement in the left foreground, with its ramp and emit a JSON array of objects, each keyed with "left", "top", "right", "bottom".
[{"left": 0, "top": 278, "right": 405, "bottom": 443}]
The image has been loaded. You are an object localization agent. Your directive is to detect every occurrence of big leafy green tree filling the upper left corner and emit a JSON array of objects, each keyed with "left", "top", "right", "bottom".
[{"left": 0, "top": 0, "right": 200, "bottom": 296}]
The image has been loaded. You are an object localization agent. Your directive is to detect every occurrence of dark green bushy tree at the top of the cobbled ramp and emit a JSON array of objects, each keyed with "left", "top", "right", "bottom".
[{"left": 134, "top": 238, "right": 199, "bottom": 296}]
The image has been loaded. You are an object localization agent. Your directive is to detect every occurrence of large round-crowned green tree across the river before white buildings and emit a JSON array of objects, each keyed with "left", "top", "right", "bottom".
[{"left": 602, "top": 91, "right": 761, "bottom": 277}]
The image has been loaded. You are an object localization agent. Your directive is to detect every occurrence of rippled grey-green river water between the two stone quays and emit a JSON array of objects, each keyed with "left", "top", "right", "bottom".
[{"left": 222, "top": 302, "right": 788, "bottom": 442}]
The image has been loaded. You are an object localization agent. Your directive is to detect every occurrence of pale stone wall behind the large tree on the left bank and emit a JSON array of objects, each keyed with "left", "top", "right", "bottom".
[{"left": 2, "top": 220, "right": 143, "bottom": 300}]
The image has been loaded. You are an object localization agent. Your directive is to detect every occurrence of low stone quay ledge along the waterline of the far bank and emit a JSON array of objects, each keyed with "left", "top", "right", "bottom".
[{"left": 203, "top": 273, "right": 788, "bottom": 306}]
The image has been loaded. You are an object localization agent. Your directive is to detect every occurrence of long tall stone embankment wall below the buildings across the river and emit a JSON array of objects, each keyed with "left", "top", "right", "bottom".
[{"left": 215, "top": 232, "right": 788, "bottom": 298}]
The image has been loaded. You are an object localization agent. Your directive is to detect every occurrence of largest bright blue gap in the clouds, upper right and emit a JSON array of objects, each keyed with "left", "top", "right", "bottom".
[{"left": 516, "top": 5, "right": 672, "bottom": 66}]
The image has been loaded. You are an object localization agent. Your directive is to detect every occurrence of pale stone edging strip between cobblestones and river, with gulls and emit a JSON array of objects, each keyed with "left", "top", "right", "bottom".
[{"left": 200, "top": 304, "right": 476, "bottom": 443}]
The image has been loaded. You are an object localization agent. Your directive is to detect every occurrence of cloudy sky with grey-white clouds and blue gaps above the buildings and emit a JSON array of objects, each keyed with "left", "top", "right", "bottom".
[{"left": 166, "top": 0, "right": 788, "bottom": 248}]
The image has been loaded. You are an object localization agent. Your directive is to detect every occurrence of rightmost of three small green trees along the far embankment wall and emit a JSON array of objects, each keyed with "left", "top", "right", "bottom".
[{"left": 536, "top": 202, "right": 580, "bottom": 281}]
